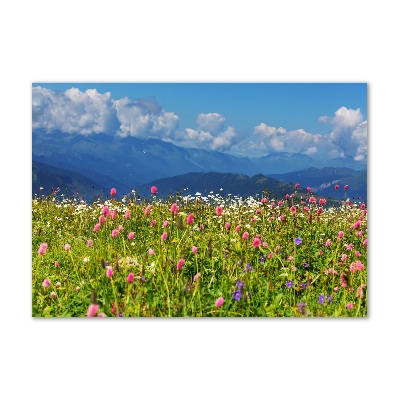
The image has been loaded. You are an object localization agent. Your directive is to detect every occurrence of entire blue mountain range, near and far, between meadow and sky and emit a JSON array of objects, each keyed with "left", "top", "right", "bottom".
[{"left": 32, "top": 130, "right": 367, "bottom": 199}]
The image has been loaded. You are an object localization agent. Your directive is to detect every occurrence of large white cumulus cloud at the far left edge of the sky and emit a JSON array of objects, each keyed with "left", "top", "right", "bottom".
[{"left": 32, "top": 86, "right": 119, "bottom": 135}]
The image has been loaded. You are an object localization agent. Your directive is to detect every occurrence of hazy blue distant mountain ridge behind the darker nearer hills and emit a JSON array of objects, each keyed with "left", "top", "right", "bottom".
[{"left": 32, "top": 130, "right": 363, "bottom": 193}]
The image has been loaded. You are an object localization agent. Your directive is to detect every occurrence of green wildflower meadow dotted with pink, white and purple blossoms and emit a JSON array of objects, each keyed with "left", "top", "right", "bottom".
[{"left": 32, "top": 185, "right": 367, "bottom": 317}]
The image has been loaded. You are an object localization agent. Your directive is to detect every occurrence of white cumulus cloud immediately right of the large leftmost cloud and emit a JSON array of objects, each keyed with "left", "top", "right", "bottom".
[{"left": 114, "top": 97, "right": 179, "bottom": 139}]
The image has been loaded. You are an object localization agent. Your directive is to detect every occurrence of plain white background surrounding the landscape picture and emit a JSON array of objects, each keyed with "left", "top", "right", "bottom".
[{"left": 0, "top": 0, "right": 400, "bottom": 400}]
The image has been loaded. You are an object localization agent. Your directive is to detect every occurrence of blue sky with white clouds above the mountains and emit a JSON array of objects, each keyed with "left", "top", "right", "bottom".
[{"left": 32, "top": 83, "right": 367, "bottom": 163}]
